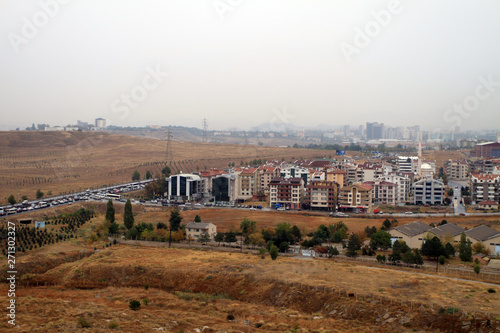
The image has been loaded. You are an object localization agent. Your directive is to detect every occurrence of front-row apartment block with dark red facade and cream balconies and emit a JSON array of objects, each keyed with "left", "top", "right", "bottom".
[{"left": 269, "top": 177, "right": 304, "bottom": 210}]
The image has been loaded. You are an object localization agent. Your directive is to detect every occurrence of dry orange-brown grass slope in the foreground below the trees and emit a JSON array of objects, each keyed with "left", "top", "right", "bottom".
[{"left": 0, "top": 245, "right": 500, "bottom": 332}]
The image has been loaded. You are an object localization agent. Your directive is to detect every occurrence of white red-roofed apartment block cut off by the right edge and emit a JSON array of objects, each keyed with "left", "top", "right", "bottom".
[{"left": 469, "top": 173, "right": 500, "bottom": 204}]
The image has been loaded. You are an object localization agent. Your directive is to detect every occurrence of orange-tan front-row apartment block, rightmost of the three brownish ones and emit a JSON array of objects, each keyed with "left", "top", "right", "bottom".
[{"left": 339, "top": 183, "right": 372, "bottom": 212}]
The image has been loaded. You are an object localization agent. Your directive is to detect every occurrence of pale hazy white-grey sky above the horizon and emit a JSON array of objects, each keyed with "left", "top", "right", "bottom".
[{"left": 0, "top": 0, "right": 500, "bottom": 130}]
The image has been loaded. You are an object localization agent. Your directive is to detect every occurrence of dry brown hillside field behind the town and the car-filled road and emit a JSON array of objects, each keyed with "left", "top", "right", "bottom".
[{"left": 0, "top": 131, "right": 333, "bottom": 204}]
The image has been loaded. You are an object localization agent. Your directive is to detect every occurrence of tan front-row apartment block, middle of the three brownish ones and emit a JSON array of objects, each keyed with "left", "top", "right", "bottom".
[{"left": 305, "top": 180, "right": 339, "bottom": 211}]
